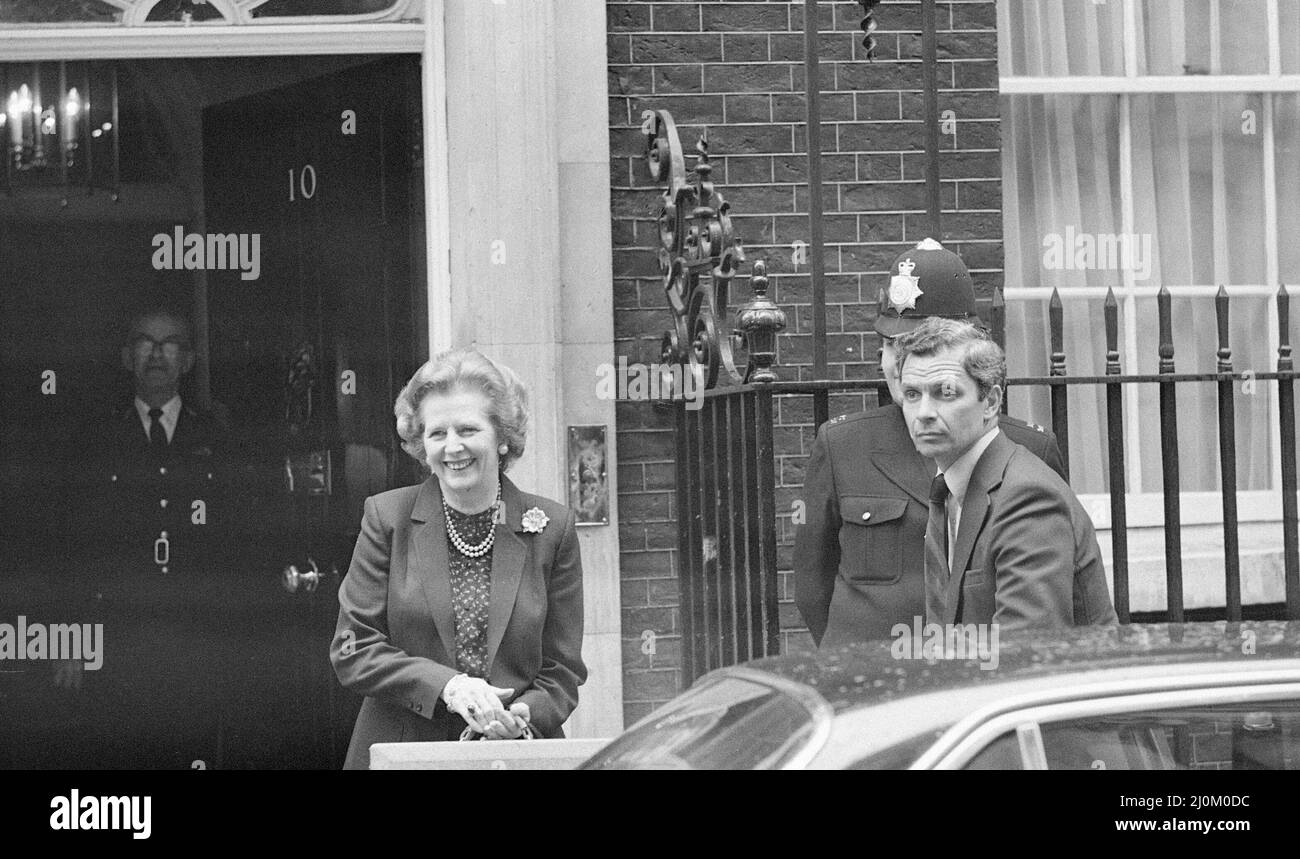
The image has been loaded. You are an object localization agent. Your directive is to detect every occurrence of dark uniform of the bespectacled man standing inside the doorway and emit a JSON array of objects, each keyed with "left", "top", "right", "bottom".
[{"left": 65, "top": 403, "right": 238, "bottom": 767}]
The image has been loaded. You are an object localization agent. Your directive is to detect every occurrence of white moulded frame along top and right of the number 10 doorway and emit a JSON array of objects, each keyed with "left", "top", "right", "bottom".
[{"left": 0, "top": 11, "right": 451, "bottom": 355}]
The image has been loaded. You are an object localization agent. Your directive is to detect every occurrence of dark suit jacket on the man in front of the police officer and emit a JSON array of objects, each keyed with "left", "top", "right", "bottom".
[{"left": 926, "top": 433, "right": 1117, "bottom": 630}]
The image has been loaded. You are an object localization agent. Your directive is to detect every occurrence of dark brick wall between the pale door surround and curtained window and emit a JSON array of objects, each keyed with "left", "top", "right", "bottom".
[{"left": 607, "top": 0, "right": 1002, "bottom": 724}]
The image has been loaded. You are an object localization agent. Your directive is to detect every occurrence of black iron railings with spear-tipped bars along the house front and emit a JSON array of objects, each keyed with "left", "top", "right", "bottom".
[{"left": 660, "top": 287, "right": 1300, "bottom": 681}]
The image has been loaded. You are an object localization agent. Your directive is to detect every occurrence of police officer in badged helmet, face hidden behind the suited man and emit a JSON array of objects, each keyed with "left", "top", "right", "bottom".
[{"left": 794, "top": 239, "right": 1066, "bottom": 647}]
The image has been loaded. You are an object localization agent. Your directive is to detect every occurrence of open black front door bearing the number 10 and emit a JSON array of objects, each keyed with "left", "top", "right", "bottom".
[{"left": 203, "top": 57, "right": 426, "bottom": 768}]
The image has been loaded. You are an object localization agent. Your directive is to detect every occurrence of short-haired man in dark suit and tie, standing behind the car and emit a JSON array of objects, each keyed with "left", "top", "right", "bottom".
[{"left": 897, "top": 318, "right": 1115, "bottom": 630}]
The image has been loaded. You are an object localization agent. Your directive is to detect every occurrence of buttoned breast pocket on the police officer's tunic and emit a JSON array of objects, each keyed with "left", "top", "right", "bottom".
[{"left": 840, "top": 495, "right": 909, "bottom": 585}]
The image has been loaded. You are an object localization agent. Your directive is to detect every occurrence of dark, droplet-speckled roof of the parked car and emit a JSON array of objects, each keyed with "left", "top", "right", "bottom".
[{"left": 714, "top": 621, "right": 1300, "bottom": 712}]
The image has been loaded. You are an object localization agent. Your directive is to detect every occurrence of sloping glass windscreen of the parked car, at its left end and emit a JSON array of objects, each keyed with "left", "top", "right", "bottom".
[{"left": 580, "top": 676, "right": 815, "bottom": 769}]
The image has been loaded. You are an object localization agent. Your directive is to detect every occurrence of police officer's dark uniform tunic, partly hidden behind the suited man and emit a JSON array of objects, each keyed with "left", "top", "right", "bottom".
[{"left": 794, "top": 404, "right": 1065, "bottom": 647}]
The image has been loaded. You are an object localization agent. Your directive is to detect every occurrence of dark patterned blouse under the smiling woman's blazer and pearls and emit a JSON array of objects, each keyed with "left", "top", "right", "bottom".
[{"left": 447, "top": 507, "right": 495, "bottom": 680}]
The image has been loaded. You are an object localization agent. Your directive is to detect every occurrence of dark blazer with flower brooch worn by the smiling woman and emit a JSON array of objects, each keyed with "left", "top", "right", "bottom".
[{"left": 330, "top": 476, "right": 586, "bottom": 769}]
